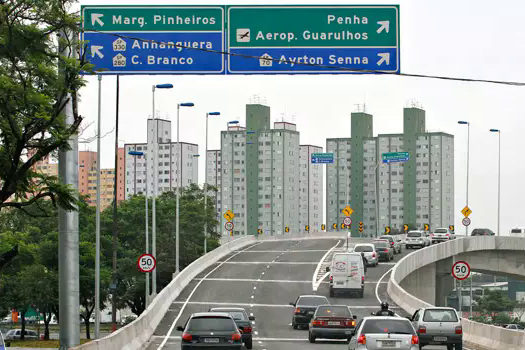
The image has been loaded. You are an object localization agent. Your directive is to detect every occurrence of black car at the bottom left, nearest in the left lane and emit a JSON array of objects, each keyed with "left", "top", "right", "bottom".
[{"left": 177, "top": 312, "right": 242, "bottom": 350}]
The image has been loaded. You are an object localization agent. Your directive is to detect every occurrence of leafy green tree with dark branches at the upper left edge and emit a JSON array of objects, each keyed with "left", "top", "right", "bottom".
[{"left": 0, "top": 0, "right": 92, "bottom": 214}]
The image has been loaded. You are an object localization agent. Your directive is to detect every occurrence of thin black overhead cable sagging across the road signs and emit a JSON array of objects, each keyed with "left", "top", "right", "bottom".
[{"left": 82, "top": 30, "right": 525, "bottom": 86}]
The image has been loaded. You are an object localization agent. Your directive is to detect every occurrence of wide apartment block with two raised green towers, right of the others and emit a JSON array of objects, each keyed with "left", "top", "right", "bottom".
[{"left": 327, "top": 108, "right": 454, "bottom": 235}]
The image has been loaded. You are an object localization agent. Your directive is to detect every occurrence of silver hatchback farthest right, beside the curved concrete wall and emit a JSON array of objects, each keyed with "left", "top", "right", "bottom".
[{"left": 410, "top": 307, "right": 463, "bottom": 350}]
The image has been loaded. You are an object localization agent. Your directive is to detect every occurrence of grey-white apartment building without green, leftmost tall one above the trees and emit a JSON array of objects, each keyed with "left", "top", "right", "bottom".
[{"left": 124, "top": 119, "right": 199, "bottom": 198}]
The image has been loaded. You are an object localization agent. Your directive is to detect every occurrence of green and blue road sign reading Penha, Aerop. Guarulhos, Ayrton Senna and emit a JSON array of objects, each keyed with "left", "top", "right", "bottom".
[{"left": 226, "top": 5, "right": 400, "bottom": 74}]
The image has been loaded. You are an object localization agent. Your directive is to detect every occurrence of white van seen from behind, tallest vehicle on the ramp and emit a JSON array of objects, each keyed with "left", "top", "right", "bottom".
[{"left": 329, "top": 252, "right": 365, "bottom": 298}]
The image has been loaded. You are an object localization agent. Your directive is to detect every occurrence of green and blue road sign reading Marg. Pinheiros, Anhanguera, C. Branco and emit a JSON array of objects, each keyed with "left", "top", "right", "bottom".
[{"left": 81, "top": 5, "right": 225, "bottom": 74}]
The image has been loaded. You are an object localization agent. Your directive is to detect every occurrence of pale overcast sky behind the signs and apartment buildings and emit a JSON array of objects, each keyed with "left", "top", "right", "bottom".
[{"left": 80, "top": 0, "right": 525, "bottom": 234}]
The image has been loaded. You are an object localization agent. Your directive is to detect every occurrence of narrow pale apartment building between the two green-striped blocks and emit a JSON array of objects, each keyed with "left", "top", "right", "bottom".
[{"left": 299, "top": 145, "right": 323, "bottom": 231}]
